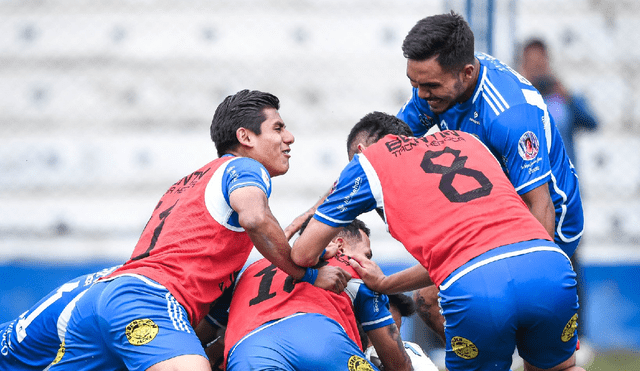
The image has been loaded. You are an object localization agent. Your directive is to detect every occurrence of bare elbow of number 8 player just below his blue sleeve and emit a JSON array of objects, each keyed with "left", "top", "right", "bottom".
[{"left": 291, "top": 218, "right": 342, "bottom": 267}]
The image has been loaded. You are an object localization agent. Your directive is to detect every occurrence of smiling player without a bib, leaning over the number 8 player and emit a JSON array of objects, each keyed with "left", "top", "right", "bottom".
[{"left": 397, "top": 12, "right": 584, "bottom": 337}]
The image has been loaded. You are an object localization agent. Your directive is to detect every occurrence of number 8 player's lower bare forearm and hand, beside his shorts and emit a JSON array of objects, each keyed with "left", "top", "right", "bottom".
[{"left": 349, "top": 257, "right": 433, "bottom": 295}]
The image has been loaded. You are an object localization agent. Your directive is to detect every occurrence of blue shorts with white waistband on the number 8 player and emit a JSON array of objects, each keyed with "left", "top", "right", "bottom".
[{"left": 439, "top": 240, "right": 578, "bottom": 371}]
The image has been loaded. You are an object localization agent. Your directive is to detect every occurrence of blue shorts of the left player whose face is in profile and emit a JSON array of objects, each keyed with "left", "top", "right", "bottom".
[{"left": 50, "top": 276, "right": 206, "bottom": 371}]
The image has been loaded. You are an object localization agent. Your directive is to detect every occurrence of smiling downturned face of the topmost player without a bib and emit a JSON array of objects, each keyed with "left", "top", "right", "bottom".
[{"left": 407, "top": 57, "right": 465, "bottom": 114}]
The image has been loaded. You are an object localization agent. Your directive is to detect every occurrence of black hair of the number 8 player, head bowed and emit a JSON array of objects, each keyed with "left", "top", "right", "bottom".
[{"left": 347, "top": 111, "right": 413, "bottom": 158}]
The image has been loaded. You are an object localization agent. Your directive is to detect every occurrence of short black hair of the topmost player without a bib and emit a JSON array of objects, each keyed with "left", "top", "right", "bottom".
[{"left": 402, "top": 11, "right": 474, "bottom": 72}]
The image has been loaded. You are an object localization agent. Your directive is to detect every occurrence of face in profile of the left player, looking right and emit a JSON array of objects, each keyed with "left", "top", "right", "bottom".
[{"left": 252, "top": 108, "right": 295, "bottom": 177}]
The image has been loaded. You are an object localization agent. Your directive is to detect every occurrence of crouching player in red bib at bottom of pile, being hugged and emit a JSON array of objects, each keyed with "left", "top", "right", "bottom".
[{"left": 225, "top": 219, "right": 411, "bottom": 371}]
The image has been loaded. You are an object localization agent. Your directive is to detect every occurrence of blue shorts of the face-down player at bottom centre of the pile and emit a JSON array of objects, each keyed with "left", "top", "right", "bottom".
[{"left": 227, "top": 313, "right": 378, "bottom": 371}]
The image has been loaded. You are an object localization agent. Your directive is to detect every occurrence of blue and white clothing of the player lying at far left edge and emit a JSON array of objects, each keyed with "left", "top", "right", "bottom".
[{"left": 0, "top": 267, "right": 117, "bottom": 370}]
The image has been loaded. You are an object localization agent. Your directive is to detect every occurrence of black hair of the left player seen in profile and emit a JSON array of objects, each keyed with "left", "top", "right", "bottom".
[{"left": 210, "top": 89, "right": 280, "bottom": 157}]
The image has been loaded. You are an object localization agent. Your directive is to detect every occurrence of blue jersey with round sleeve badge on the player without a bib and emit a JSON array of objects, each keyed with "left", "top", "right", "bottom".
[{"left": 397, "top": 53, "right": 584, "bottom": 255}]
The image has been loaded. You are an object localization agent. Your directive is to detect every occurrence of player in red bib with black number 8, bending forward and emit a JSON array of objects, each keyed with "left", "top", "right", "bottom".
[{"left": 291, "top": 112, "right": 583, "bottom": 371}]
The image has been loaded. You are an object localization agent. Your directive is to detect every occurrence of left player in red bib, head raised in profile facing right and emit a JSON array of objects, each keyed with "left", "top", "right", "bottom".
[{"left": 51, "top": 90, "right": 350, "bottom": 371}]
